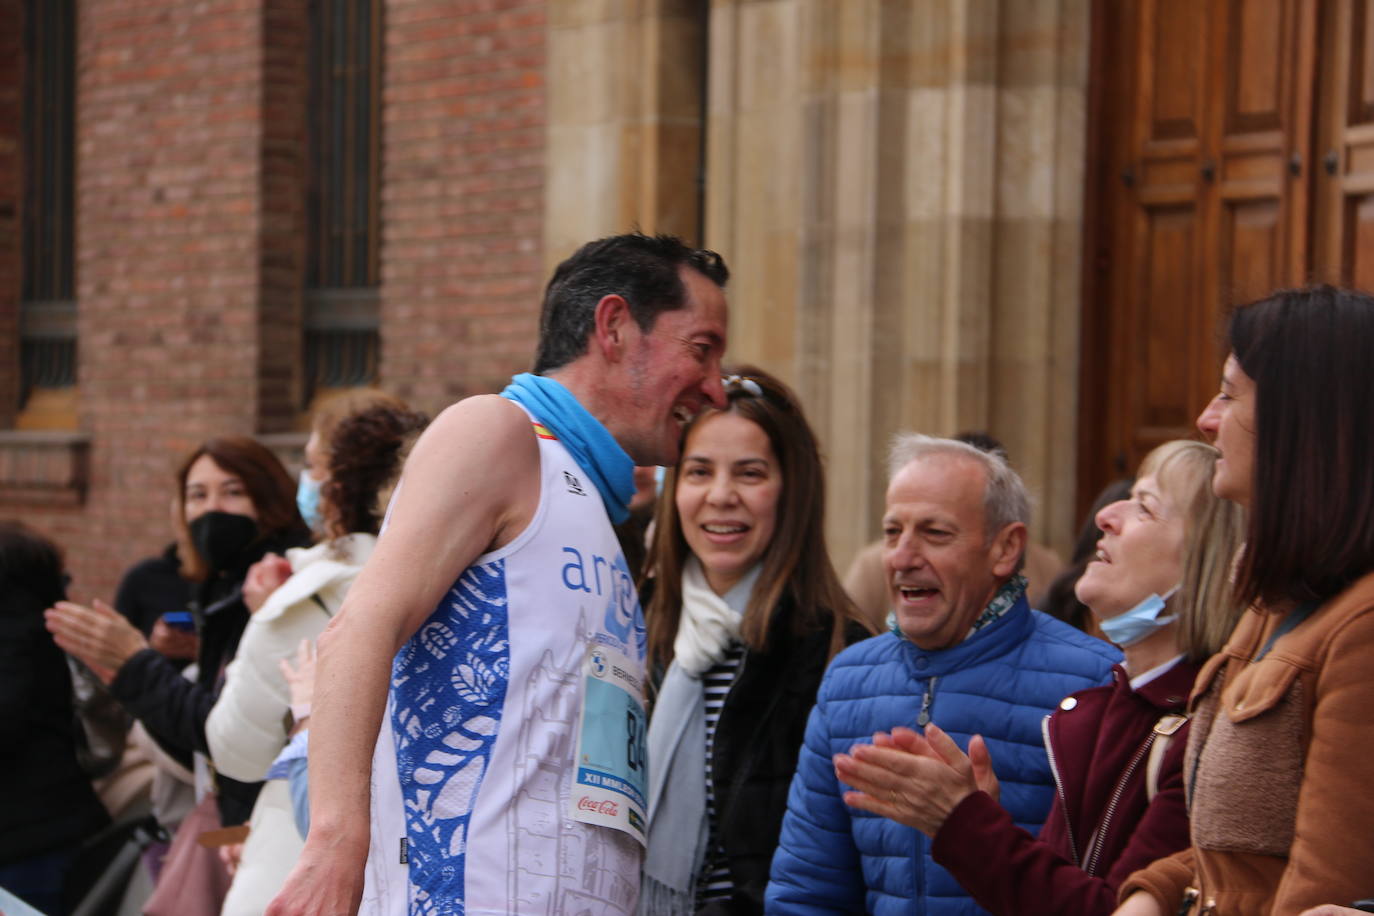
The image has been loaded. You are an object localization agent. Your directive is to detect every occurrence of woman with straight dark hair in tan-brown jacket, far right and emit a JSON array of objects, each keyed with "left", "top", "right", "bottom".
[{"left": 1118, "top": 286, "right": 1374, "bottom": 913}]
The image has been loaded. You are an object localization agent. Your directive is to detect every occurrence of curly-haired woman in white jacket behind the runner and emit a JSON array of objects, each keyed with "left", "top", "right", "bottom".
[{"left": 206, "top": 393, "right": 427, "bottom": 916}]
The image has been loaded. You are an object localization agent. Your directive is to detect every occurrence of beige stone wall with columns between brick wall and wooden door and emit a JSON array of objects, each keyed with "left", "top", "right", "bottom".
[{"left": 545, "top": 0, "right": 1088, "bottom": 566}]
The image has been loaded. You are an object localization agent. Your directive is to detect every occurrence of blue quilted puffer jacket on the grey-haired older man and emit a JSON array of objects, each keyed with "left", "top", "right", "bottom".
[{"left": 767, "top": 597, "right": 1121, "bottom": 916}]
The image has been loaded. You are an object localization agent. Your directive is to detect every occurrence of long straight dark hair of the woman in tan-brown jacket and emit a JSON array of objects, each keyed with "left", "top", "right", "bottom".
[{"left": 1228, "top": 286, "right": 1374, "bottom": 606}]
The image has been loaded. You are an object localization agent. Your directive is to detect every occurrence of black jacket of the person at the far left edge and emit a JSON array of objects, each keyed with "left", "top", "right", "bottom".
[{"left": 0, "top": 582, "right": 110, "bottom": 864}]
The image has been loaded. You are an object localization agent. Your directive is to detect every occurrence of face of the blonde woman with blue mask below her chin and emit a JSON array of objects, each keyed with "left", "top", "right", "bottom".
[{"left": 1074, "top": 475, "right": 1184, "bottom": 619}]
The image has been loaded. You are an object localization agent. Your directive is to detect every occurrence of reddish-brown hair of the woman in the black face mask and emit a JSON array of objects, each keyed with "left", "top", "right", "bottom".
[{"left": 176, "top": 435, "right": 311, "bottom": 581}]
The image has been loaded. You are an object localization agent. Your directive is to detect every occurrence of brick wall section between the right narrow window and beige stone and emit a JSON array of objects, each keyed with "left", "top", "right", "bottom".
[{"left": 382, "top": 0, "right": 545, "bottom": 412}]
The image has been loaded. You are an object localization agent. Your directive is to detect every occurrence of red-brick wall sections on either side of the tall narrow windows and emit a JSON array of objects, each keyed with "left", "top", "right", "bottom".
[{"left": 0, "top": 0, "right": 544, "bottom": 599}]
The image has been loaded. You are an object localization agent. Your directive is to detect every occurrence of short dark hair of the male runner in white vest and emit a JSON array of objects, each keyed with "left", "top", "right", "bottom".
[{"left": 534, "top": 232, "right": 730, "bottom": 374}]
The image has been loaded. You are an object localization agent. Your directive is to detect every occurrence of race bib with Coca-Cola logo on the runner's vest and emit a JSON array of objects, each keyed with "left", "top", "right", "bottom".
[{"left": 569, "top": 643, "right": 649, "bottom": 845}]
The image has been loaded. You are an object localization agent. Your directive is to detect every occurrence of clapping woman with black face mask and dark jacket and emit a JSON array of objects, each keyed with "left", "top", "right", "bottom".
[{"left": 47, "top": 437, "right": 309, "bottom": 825}]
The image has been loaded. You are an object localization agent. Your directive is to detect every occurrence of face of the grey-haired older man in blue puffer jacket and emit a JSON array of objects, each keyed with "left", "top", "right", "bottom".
[{"left": 882, "top": 455, "right": 1020, "bottom": 650}]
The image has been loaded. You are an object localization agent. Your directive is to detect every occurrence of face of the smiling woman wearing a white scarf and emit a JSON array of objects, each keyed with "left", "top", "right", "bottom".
[{"left": 676, "top": 413, "right": 782, "bottom": 595}]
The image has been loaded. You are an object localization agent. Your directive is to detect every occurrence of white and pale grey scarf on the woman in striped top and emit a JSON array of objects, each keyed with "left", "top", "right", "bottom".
[{"left": 639, "top": 555, "right": 758, "bottom": 916}]
